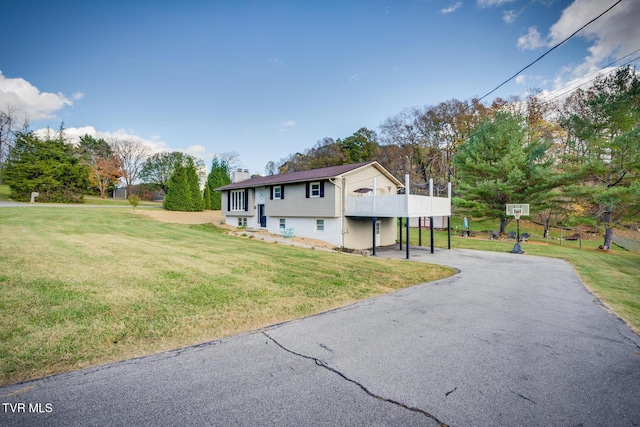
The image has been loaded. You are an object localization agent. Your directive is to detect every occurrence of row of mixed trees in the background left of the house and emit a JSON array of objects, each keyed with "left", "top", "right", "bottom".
[{"left": 0, "top": 122, "right": 237, "bottom": 211}]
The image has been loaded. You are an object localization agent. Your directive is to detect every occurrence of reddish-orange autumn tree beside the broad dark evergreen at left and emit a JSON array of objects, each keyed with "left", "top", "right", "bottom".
[{"left": 78, "top": 135, "right": 122, "bottom": 199}]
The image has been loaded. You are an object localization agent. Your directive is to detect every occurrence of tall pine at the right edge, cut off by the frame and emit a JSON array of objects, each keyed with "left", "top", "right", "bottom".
[{"left": 562, "top": 67, "right": 640, "bottom": 248}]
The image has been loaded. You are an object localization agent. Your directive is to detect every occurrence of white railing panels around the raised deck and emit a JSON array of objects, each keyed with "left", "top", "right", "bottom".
[{"left": 345, "top": 194, "right": 451, "bottom": 218}]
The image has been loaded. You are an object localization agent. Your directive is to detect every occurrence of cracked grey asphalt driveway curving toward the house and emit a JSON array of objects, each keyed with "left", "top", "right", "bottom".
[{"left": 0, "top": 250, "right": 640, "bottom": 426}]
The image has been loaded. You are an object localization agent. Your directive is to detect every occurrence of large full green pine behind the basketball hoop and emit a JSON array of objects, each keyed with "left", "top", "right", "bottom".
[{"left": 454, "top": 113, "right": 558, "bottom": 233}]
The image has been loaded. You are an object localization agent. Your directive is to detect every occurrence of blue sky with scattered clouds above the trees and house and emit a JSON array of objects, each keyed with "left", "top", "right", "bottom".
[{"left": 0, "top": 0, "right": 640, "bottom": 173}]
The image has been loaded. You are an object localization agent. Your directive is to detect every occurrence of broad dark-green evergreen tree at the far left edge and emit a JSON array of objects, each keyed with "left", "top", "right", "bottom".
[{"left": 2, "top": 133, "right": 89, "bottom": 203}]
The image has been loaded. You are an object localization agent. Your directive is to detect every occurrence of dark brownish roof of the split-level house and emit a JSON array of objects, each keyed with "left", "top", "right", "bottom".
[{"left": 216, "top": 162, "right": 402, "bottom": 191}]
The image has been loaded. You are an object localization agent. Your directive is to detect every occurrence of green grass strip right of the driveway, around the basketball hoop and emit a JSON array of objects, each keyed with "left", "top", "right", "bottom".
[{"left": 410, "top": 218, "right": 640, "bottom": 334}]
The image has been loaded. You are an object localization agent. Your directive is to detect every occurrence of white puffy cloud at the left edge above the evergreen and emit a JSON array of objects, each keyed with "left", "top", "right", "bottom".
[{"left": 0, "top": 71, "right": 73, "bottom": 120}]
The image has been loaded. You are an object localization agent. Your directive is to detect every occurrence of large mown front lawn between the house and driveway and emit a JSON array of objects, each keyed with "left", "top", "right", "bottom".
[{"left": 0, "top": 206, "right": 453, "bottom": 384}]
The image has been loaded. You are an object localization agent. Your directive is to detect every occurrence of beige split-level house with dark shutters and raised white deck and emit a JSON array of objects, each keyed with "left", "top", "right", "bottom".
[{"left": 216, "top": 161, "right": 451, "bottom": 249}]
